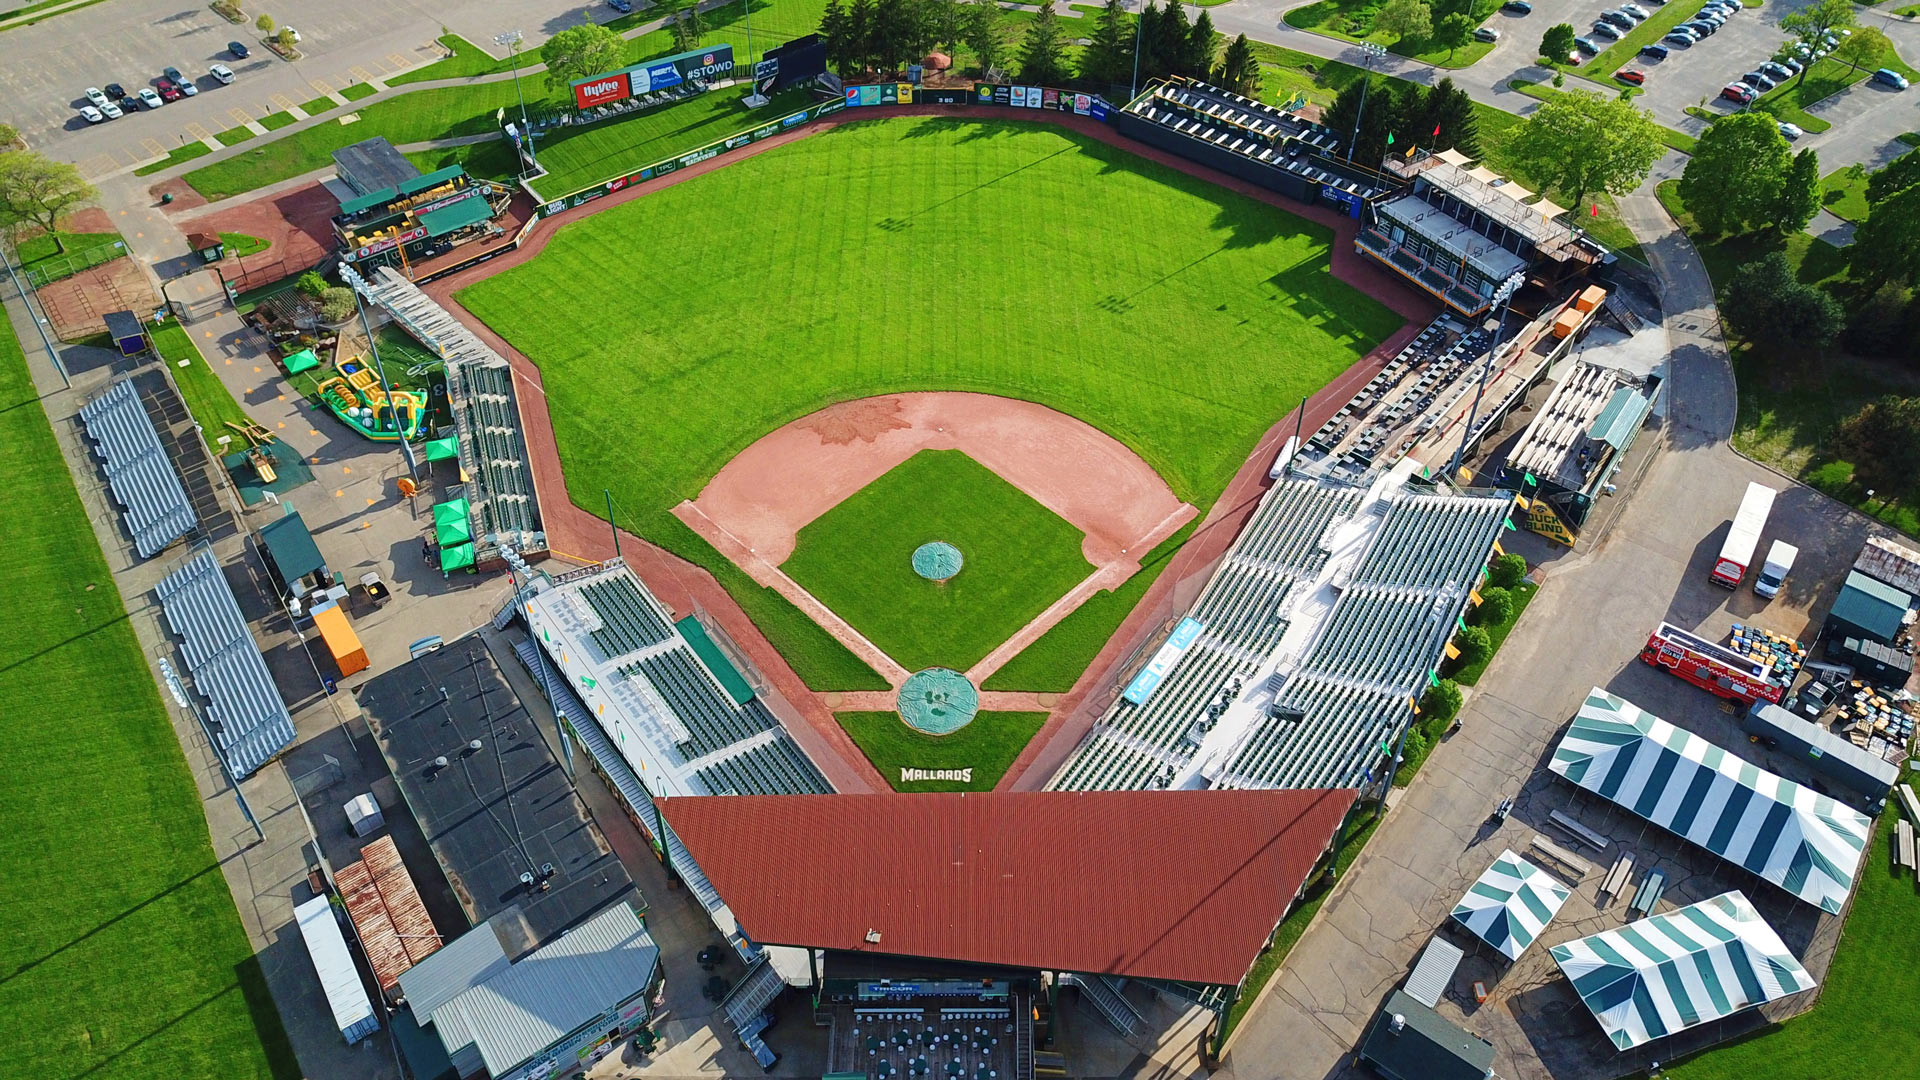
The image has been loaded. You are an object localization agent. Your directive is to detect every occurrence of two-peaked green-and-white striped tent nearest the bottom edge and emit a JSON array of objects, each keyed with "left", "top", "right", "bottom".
[{"left": 1553, "top": 892, "right": 1812, "bottom": 1049}]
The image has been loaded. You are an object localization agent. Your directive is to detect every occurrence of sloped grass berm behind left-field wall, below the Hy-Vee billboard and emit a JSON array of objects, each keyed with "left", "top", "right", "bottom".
[{"left": 534, "top": 88, "right": 814, "bottom": 200}]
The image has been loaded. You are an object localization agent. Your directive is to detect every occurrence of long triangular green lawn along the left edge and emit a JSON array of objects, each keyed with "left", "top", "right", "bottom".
[{"left": 0, "top": 303, "right": 300, "bottom": 1080}]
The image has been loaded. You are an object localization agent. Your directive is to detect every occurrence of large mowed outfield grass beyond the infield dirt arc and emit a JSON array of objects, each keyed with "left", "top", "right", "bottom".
[{"left": 459, "top": 117, "right": 1402, "bottom": 690}]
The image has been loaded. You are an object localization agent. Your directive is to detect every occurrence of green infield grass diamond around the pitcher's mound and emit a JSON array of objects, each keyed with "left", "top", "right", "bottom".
[{"left": 780, "top": 450, "right": 1094, "bottom": 671}]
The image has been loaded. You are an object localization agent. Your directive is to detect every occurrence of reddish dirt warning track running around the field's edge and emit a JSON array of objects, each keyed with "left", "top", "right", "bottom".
[{"left": 424, "top": 106, "right": 1438, "bottom": 792}]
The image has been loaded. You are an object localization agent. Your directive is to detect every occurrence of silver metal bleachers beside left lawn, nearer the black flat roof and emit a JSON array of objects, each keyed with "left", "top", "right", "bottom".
[{"left": 154, "top": 552, "right": 294, "bottom": 778}]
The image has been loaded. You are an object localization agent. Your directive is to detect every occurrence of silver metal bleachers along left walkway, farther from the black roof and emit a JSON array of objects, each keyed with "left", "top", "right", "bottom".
[{"left": 81, "top": 379, "right": 200, "bottom": 559}]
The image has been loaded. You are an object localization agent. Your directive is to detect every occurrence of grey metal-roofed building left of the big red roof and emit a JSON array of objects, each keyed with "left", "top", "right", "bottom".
[{"left": 430, "top": 903, "right": 660, "bottom": 1080}]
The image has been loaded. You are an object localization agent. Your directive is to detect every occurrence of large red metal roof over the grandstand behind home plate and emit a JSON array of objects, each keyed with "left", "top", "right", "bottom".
[{"left": 660, "top": 790, "right": 1356, "bottom": 986}]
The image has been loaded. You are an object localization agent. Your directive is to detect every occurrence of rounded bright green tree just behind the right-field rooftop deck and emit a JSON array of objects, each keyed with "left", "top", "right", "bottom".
[{"left": 1507, "top": 90, "right": 1667, "bottom": 217}]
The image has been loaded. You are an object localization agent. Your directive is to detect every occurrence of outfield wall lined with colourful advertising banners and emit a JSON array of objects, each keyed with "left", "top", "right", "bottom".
[{"left": 520, "top": 83, "right": 1117, "bottom": 217}]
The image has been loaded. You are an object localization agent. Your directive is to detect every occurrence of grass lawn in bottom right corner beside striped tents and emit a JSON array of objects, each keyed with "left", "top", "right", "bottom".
[{"left": 1663, "top": 773, "right": 1920, "bottom": 1080}]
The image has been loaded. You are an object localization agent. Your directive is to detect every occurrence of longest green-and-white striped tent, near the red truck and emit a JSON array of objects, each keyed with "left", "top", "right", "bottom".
[{"left": 1548, "top": 686, "right": 1872, "bottom": 911}]
